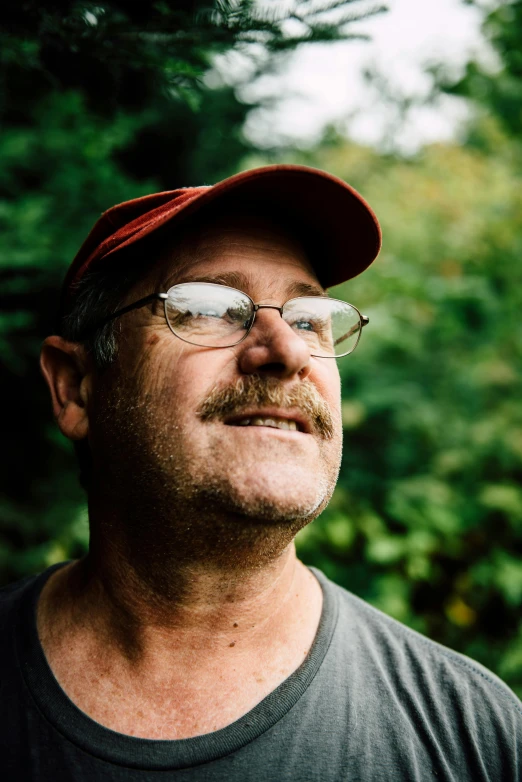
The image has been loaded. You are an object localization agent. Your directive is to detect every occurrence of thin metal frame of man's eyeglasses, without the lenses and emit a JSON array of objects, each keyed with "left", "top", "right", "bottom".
[{"left": 89, "top": 280, "right": 370, "bottom": 358}]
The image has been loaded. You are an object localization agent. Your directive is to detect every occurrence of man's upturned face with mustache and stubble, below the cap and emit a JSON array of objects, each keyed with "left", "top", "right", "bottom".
[{"left": 90, "top": 211, "right": 341, "bottom": 548}]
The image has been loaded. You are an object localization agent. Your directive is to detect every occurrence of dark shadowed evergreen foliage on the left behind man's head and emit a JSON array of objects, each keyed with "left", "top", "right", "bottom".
[{"left": 0, "top": 0, "right": 378, "bottom": 582}]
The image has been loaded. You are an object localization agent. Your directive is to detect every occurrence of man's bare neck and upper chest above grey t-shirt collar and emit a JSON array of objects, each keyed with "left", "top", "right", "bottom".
[{"left": 38, "top": 506, "right": 322, "bottom": 738}]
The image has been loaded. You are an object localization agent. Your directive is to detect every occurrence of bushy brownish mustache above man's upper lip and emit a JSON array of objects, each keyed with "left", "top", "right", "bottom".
[{"left": 197, "top": 375, "right": 335, "bottom": 440}]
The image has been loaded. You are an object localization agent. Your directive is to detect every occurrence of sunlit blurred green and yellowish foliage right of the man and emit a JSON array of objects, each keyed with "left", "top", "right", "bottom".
[{"left": 284, "top": 137, "right": 522, "bottom": 693}]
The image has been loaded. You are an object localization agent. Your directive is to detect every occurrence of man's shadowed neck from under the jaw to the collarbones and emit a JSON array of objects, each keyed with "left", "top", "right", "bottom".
[{"left": 77, "top": 480, "right": 312, "bottom": 626}]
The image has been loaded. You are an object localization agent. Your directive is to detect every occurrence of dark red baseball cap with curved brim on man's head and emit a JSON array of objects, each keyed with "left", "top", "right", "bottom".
[{"left": 62, "top": 165, "right": 381, "bottom": 311}]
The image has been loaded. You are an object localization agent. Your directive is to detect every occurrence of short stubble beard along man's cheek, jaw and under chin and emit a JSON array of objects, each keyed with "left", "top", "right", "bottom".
[{"left": 90, "top": 379, "right": 340, "bottom": 585}]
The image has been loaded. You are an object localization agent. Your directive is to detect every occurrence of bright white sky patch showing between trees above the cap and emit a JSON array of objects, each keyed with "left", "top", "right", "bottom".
[{"left": 218, "top": 0, "right": 494, "bottom": 152}]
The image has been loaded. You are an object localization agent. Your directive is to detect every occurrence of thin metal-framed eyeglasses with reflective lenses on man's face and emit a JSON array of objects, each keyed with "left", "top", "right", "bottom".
[{"left": 95, "top": 282, "right": 369, "bottom": 358}]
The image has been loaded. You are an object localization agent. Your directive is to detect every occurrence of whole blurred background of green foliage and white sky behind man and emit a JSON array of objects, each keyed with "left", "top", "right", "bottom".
[{"left": 0, "top": 0, "right": 522, "bottom": 695}]
